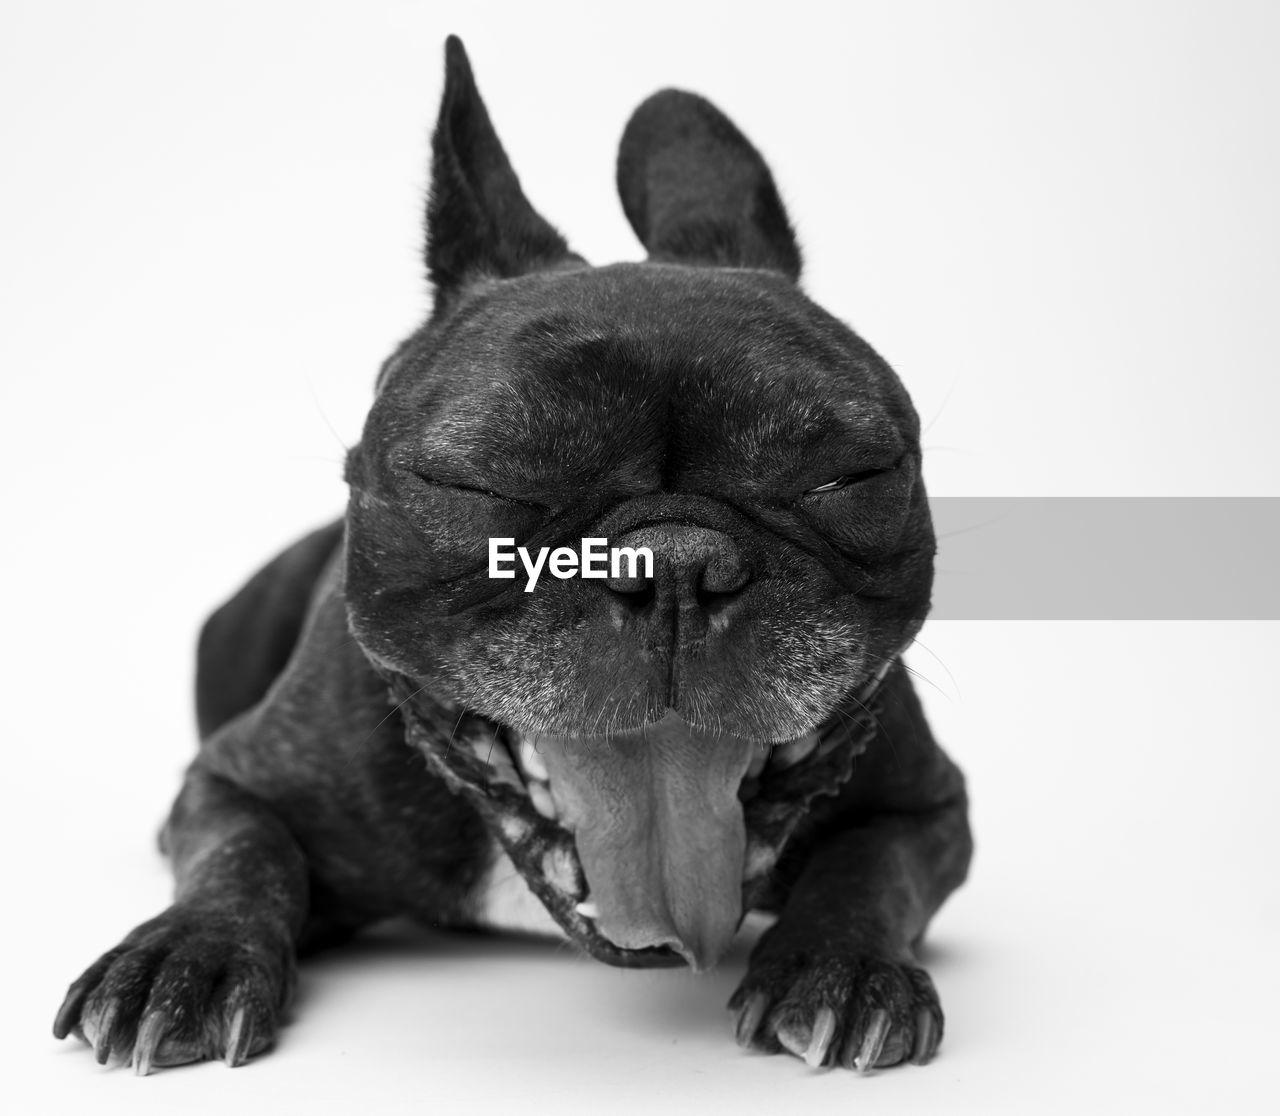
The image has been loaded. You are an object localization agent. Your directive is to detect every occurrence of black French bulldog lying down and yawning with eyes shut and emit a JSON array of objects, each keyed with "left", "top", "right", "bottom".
[{"left": 54, "top": 38, "right": 972, "bottom": 1074}]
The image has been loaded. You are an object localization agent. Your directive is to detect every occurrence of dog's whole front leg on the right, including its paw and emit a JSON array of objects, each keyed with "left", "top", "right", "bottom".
[{"left": 730, "top": 672, "right": 973, "bottom": 1070}]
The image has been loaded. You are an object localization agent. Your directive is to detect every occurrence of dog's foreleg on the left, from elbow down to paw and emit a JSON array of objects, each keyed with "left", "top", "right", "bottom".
[{"left": 54, "top": 760, "right": 307, "bottom": 1074}]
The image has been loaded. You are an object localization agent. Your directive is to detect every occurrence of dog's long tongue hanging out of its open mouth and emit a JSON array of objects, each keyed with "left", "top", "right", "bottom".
[{"left": 538, "top": 713, "right": 759, "bottom": 970}]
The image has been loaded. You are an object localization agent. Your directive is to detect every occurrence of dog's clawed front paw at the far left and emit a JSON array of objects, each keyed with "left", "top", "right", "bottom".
[{"left": 54, "top": 906, "right": 296, "bottom": 1075}]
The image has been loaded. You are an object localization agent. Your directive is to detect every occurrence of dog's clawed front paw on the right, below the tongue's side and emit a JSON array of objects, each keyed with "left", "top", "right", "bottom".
[{"left": 728, "top": 952, "right": 942, "bottom": 1072}]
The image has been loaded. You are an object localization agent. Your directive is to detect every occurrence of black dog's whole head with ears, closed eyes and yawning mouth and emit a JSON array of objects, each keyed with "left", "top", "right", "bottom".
[{"left": 347, "top": 40, "right": 933, "bottom": 965}]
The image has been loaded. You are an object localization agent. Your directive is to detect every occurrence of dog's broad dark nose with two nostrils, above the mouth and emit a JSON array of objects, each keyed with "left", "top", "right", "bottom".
[{"left": 604, "top": 523, "right": 751, "bottom": 616}]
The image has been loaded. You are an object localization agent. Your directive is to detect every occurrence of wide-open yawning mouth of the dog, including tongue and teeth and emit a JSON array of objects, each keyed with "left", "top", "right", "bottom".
[{"left": 388, "top": 660, "right": 892, "bottom": 970}]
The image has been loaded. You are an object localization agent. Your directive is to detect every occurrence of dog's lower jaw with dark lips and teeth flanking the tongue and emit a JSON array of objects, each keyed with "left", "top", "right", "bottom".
[{"left": 379, "top": 659, "right": 893, "bottom": 968}]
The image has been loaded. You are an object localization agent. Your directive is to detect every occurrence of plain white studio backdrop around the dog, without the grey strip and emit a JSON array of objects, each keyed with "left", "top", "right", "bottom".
[{"left": 0, "top": 0, "right": 1280, "bottom": 1113}]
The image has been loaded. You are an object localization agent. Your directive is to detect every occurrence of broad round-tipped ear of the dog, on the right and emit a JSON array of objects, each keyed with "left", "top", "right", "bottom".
[{"left": 618, "top": 90, "right": 800, "bottom": 279}]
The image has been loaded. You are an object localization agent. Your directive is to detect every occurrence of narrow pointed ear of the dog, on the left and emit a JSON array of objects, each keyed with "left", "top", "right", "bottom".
[{"left": 426, "top": 35, "right": 580, "bottom": 312}]
